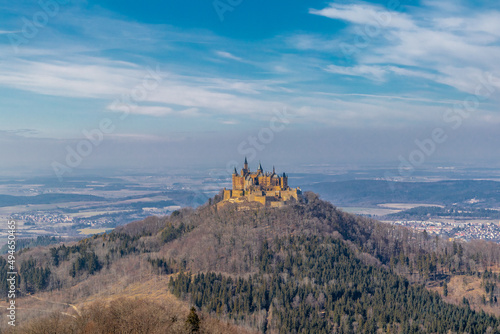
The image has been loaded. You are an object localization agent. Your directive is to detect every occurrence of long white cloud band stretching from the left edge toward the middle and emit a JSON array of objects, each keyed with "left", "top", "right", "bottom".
[{"left": 0, "top": 57, "right": 290, "bottom": 120}]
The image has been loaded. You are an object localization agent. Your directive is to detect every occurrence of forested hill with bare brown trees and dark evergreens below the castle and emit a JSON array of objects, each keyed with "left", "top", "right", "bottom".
[{"left": 4, "top": 193, "right": 500, "bottom": 334}]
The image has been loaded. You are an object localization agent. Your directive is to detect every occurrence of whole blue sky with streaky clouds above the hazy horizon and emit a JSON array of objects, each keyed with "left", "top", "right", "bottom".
[{"left": 0, "top": 0, "right": 500, "bottom": 177}]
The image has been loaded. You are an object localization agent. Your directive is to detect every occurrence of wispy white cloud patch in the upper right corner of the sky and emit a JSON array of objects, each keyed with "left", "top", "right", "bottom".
[{"left": 310, "top": 1, "right": 500, "bottom": 93}]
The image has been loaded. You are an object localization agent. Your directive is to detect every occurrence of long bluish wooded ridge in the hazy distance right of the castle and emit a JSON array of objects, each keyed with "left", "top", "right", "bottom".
[{"left": 303, "top": 180, "right": 500, "bottom": 207}]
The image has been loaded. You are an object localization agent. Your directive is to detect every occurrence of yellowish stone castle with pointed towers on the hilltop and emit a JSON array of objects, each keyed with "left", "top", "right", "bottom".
[{"left": 219, "top": 158, "right": 302, "bottom": 207}]
